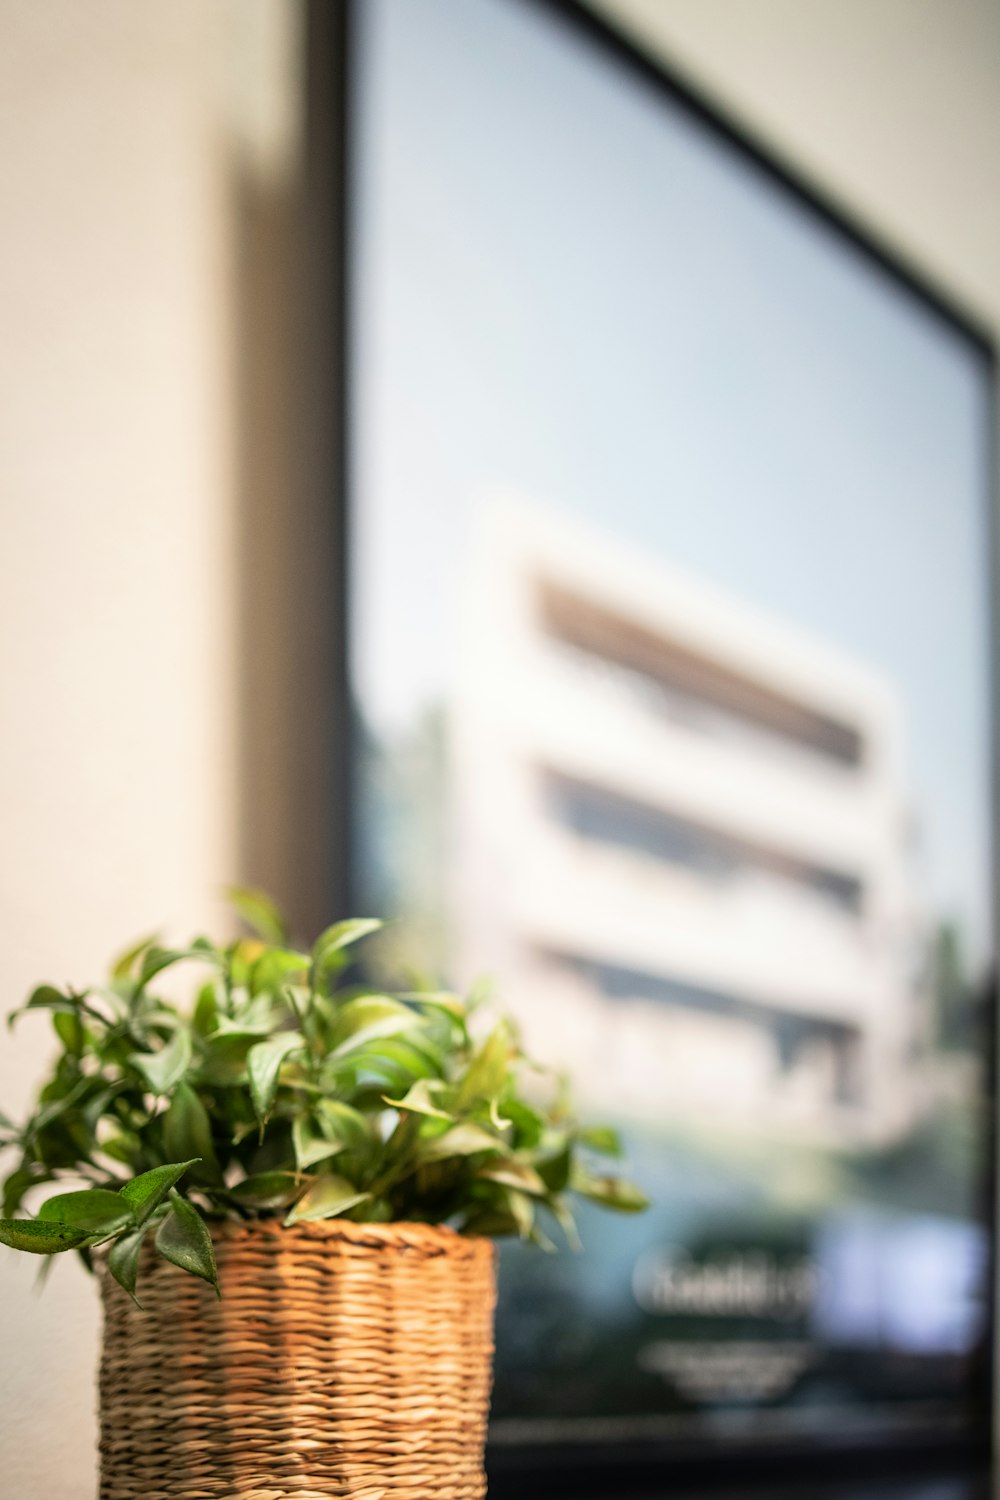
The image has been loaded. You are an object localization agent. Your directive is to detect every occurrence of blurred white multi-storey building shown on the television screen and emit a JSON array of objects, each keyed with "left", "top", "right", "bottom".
[{"left": 450, "top": 500, "right": 918, "bottom": 1142}]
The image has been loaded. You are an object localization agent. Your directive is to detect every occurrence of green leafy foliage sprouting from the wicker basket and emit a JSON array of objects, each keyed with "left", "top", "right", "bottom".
[{"left": 0, "top": 890, "right": 646, "bottom": 1296}]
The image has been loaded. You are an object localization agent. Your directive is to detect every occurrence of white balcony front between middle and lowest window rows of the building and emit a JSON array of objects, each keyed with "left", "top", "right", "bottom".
[{"left": 510, "top": 824, "right": 906, "bottom": 1032}]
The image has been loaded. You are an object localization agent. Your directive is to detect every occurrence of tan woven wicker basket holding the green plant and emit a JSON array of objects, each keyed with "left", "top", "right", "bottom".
[{"left": 100, "top": 1221, "right": 495, "bottom": 1500}]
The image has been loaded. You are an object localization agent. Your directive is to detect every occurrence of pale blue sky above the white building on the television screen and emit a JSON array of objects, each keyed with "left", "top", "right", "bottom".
[{"left": 352, "top": 0, "right": 990, "bottom": 948}]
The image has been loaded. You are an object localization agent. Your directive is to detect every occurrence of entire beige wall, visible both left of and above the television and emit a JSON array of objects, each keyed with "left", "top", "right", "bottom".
[{"left": 0, "top": 0, "right": 1000, "bottom": 1500}]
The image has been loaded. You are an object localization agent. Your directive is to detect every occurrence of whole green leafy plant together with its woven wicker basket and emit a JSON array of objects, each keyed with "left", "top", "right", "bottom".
[{"left": 0, "top": 891, "right": 645, "bottom": 1500}]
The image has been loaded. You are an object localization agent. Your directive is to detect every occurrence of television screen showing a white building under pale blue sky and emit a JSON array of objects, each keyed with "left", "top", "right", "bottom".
[{"left": 310, "top": 0, "right": 996, "bottom": 1494}]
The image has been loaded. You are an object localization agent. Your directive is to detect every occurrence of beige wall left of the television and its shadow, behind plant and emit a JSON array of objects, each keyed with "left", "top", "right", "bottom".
[{"left": 0, "top": 0, "right": 296, "bottom": 1500}]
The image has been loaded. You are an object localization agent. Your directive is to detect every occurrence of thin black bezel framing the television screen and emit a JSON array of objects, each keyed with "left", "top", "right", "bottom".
[{"left": 303, "top": 0, "right": 1000, "bottom": 1482}]
